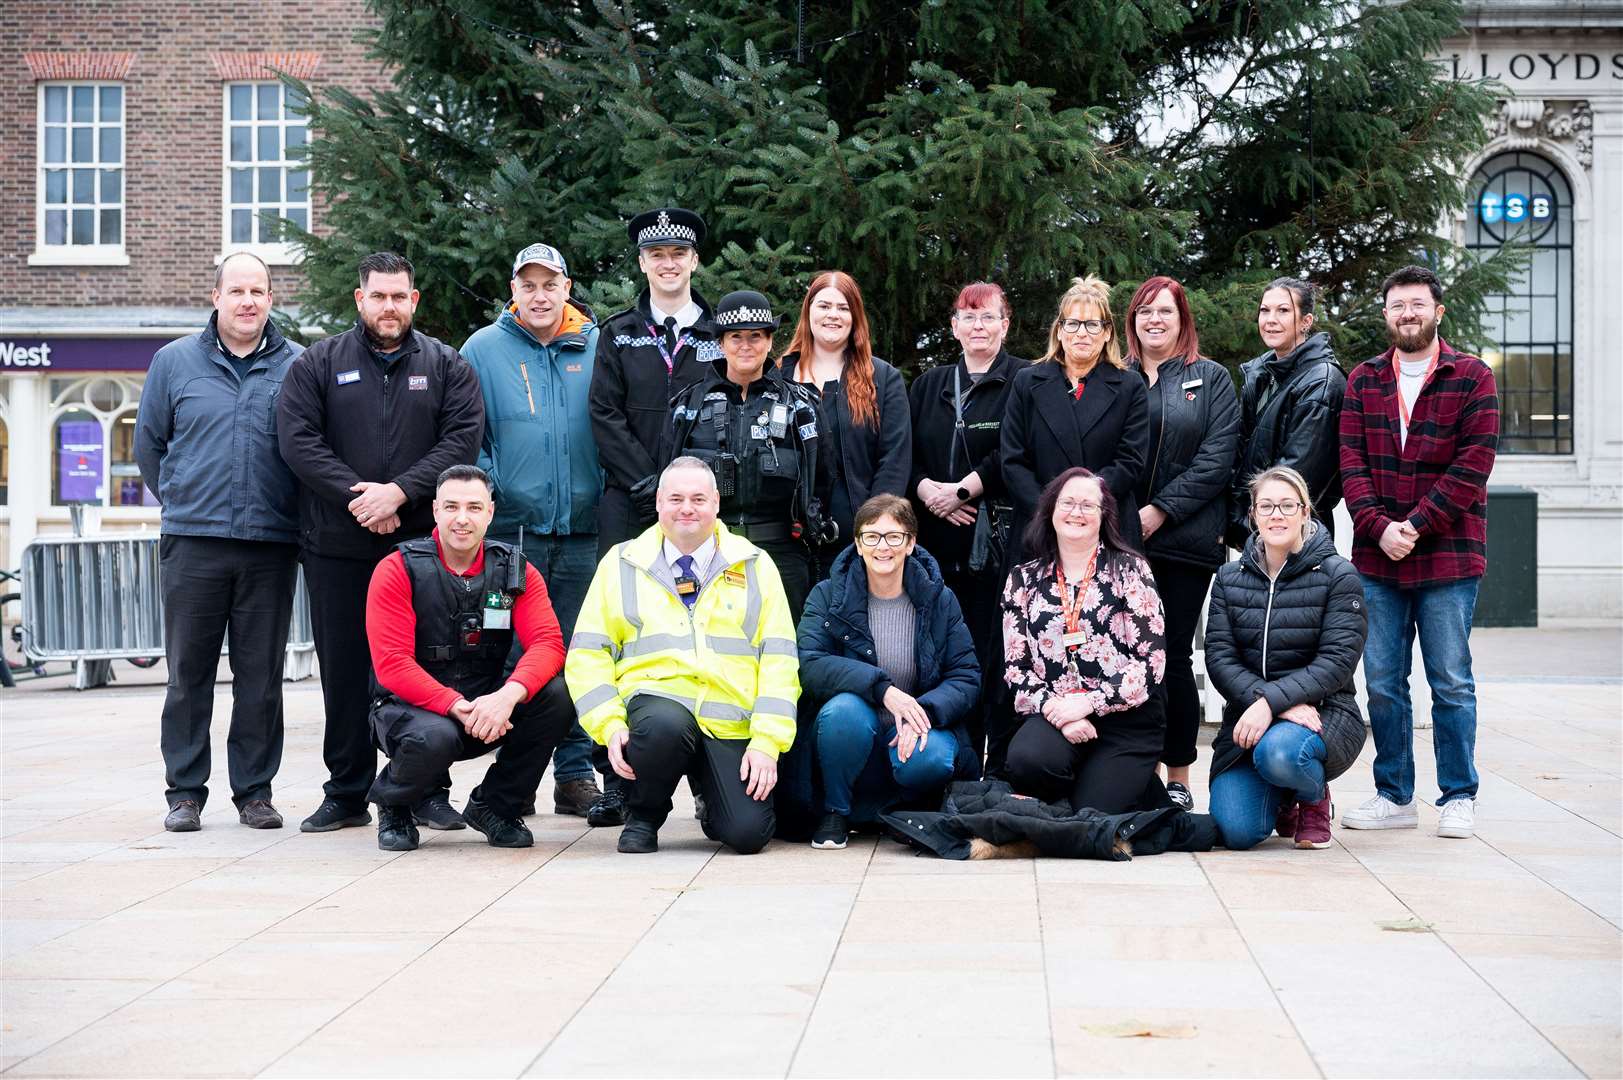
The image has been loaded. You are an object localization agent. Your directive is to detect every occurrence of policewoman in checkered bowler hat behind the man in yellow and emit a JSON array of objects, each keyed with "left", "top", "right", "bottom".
[{"left": 661, "top": 291, "right": 834, "bottom": 622}]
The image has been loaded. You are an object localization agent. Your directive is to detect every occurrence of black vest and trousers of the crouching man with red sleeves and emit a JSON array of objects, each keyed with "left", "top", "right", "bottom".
[{"left": 367, "top": 538, "right": 575, "bottom": 820}]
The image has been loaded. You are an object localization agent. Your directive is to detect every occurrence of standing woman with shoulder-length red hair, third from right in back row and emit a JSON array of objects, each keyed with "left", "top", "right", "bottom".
[{"left": 1126, "top": 276, "right": 1240, "bottom": 810}]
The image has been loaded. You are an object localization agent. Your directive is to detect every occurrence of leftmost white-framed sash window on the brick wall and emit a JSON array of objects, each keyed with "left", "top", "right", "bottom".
[{"left": 36, "top": 83, "right": 125, "bottom": 261}]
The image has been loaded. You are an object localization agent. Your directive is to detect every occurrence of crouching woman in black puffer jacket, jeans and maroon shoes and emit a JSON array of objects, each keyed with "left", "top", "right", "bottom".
[{"left": 1206, "top": 466, "right": 1367, "bottom": 849}]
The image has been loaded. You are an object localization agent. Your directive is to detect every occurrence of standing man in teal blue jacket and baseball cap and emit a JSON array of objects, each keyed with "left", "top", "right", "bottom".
[{"left": 461, "top": 244, "right": 618, "bottom": 823}]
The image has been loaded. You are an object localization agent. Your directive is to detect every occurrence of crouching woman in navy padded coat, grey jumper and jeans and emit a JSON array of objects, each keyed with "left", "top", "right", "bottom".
[{"left": 799, "top": 495, "right": 980, "bottom": 848}]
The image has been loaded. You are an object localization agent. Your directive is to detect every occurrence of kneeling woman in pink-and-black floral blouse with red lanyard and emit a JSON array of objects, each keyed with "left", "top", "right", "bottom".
[{"left": 1003, "top": 468, "right": 1170, "bottom": 814}]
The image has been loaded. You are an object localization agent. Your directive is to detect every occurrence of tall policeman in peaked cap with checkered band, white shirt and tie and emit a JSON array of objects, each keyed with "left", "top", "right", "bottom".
[{"left": 589, "top": 206, "right": 721, "bottom": 557}]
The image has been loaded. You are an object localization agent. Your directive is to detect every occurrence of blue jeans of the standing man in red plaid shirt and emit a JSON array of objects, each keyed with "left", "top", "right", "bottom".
[{"left": 1363, "top": 578, "right": 1482, "bottom": 806}]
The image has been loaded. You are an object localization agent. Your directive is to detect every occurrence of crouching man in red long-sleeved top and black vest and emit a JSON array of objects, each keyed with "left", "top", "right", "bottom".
[{"left": 367, "top": 464, "right": 575, "bottom": 851}]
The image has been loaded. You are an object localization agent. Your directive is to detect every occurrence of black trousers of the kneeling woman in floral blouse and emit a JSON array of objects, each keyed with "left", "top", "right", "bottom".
[{"left": 1006, "top": 695, "right": 1170, "bottom": 814}]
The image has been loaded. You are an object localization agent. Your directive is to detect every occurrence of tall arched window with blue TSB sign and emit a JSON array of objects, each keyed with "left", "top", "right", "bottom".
[{"left": 1466, "top": 153, "right": 1573, "bottom": 453}]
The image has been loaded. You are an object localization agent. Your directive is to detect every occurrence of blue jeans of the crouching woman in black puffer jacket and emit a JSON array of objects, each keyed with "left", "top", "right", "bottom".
[{"left": 1209, "top": 719, "right": 1326, "bottom": 851}]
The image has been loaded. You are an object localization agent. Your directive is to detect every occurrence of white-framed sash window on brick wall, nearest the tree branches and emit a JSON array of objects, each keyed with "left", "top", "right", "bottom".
[{"left": 221, "top": 83, "right": 310, "bottom": 261}]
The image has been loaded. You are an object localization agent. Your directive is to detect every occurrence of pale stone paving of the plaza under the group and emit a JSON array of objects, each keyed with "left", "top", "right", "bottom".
[{"left": 0, "top": 627, "right": 1623, "bottom": 1077}]
